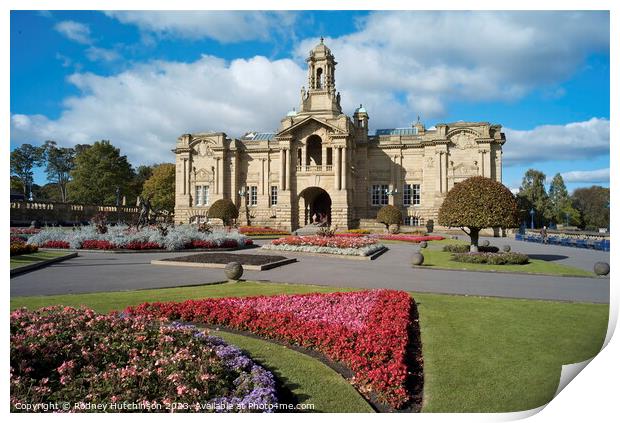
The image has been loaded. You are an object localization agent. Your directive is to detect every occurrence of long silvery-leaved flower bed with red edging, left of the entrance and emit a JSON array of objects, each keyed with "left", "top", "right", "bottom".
[{"left": 28, "top": 225, "right": 252, "bottom": 251}]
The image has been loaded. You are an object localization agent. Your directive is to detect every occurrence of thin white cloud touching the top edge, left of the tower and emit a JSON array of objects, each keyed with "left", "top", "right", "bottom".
[{"left": 106, "top": 11, "right": 294, "bottom": 43}]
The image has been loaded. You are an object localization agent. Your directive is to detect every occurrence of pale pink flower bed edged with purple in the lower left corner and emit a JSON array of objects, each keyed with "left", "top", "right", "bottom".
[{"left": 10, "top": 307, "right": 277, "bottom": 411}]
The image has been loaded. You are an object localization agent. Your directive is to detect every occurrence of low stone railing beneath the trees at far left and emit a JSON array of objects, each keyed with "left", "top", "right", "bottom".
[{"left": 11, "top": 201, "right": 140, "bottom": 226}]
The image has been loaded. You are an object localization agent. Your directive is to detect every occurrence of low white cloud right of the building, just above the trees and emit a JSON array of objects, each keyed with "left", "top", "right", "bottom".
[{"left": 504, "top": 118, "right": 609, "bottom": 166}]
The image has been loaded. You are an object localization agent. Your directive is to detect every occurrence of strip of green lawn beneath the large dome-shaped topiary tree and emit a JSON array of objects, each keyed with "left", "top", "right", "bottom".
[{"left": 422, "top": 240, "right": 596, "bottom": 277}]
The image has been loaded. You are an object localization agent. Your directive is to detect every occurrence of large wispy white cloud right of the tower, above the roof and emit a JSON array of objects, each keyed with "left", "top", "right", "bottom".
[{"left": 295, "top": 11, "right": 609, "bottom": 125}]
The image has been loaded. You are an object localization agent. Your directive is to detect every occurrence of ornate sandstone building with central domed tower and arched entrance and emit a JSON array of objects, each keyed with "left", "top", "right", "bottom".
[{"left": 173, "top": 39, "right": 505, "bottom": 230}]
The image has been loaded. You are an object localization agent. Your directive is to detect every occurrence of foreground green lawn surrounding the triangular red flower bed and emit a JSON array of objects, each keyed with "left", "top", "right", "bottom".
[{"left": 11, "top": 282, "right": 609, "bottom": 412}]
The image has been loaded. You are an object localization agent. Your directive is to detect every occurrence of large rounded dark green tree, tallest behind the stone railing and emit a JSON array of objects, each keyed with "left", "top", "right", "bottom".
[{"left": 69, "top": 140, "right": 133, "bottom": 205}]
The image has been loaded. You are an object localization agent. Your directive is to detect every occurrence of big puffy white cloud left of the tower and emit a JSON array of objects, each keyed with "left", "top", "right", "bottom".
[{"left": 11, "top": 56, "right": 304, "bottom": 164}]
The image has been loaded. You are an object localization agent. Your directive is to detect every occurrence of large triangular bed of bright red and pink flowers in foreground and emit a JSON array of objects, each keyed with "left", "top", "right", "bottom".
[{"left": 127, "top": 290, "right": 421, "bottom": 408}]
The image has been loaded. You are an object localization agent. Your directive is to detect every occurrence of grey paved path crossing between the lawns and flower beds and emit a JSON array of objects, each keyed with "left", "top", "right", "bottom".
[{"left": 11, "top": 238, "right": 609, "bottom": 303}]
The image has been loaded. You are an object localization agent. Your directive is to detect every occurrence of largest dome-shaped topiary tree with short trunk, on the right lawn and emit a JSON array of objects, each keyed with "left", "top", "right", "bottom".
[{"left": 438, "top": 176, "right": 519, "bottom": 252}]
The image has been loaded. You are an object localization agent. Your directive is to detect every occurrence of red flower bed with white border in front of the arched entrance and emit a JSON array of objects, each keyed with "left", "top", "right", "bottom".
[{"left": 262, "top": 235, "right": 385, "bottom": 256}]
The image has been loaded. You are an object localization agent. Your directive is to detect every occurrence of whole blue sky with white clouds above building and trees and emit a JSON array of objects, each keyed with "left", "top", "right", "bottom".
[{"left": 10, "top": 11, "right": 609, "bottom": 190}]
